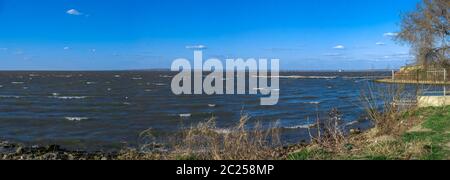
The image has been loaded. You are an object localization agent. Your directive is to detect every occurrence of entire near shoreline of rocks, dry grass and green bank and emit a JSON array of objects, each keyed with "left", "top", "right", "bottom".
[{"left": 0, "top": 106, "right": 450, "bottom": 160}]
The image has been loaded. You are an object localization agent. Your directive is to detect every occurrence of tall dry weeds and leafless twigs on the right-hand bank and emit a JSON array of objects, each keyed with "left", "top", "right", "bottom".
[{"left": 289, "top": 82, "right": 430, "bottom": 160}]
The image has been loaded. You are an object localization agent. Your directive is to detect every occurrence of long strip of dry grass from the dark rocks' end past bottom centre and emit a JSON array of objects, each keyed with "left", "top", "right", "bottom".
[{"left": 119, "top": 116, "right": 282, "bottom": 160}]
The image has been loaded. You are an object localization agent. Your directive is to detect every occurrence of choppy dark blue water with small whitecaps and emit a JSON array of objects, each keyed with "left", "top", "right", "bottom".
[{"left": 0, "top": 71, "right": 389, "bottom": 150}]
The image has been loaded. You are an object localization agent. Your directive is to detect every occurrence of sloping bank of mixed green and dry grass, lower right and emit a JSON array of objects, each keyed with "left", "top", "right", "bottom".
[{"left": 287, "top": 106, "right": 450, "bottom": 160}]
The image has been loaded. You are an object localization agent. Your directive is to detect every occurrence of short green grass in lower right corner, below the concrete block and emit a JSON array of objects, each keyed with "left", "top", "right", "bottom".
[{"left": 288, "top": 106, "right": 450, "bottom": 160}]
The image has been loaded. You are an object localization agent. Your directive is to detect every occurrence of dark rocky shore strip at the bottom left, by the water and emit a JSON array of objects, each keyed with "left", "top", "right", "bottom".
[{"left": 0, "top": 141, "right": 118, "bottom": 160}]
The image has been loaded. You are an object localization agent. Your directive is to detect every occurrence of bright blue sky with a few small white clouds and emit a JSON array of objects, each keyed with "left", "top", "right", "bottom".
[{"left": 0, "top": 0, "right": 419, "bottom": 70}]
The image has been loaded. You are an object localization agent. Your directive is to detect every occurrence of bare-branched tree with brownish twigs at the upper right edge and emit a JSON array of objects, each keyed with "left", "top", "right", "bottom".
[{"left": 396, "top": 0, "right": 450, "bottom": 68}]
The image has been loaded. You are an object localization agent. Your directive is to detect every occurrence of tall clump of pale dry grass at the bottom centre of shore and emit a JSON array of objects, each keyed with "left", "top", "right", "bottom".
[{"left": 176, "top": 116, "right": 280, "bottom": 160}]
